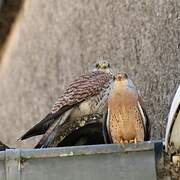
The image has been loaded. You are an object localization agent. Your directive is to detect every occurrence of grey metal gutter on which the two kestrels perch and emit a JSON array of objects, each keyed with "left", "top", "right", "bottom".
[{"left": 0, "top": 142, "right": 162, "bottom": 180}]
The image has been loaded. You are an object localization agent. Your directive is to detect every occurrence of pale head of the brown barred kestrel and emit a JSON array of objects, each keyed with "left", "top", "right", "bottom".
[{"left": 93, "top": 61, "right": 112, "bottom": 74}]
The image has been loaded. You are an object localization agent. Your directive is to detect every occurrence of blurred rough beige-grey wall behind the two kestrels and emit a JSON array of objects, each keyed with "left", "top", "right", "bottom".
[{"left": 0, "top": 0, "right": 180, "bottom": 147}]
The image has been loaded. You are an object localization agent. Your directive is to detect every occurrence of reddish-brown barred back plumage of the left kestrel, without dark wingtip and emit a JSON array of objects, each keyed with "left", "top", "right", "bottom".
[{"left": 51, "top": 71, "right": 111, "bottom": 113}]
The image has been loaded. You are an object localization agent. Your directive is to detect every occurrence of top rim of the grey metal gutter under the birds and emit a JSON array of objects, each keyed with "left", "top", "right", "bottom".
[{"left": 0, "top": 141, "right": 163, "bottom": 160}]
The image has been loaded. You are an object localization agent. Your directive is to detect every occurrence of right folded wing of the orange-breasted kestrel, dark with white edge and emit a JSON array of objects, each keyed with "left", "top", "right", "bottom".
[{"left": 138, "top": 95, "right": 151, "bottom": 141}]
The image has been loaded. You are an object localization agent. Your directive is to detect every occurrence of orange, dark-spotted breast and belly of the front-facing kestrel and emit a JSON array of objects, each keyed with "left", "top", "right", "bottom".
[{"left": 108, "top": 88, "right": 143, "bottom": 142}]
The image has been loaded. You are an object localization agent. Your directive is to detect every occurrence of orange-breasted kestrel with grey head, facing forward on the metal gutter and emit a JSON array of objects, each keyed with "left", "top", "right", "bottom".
[{"left": 104, "top": 73, "right": 149, "bottom": 143}]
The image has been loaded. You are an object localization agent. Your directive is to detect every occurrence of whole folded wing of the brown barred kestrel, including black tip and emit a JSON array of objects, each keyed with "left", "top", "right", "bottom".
[{"left": 20, "top": 71, "right": 112, "bottom": 140}]
